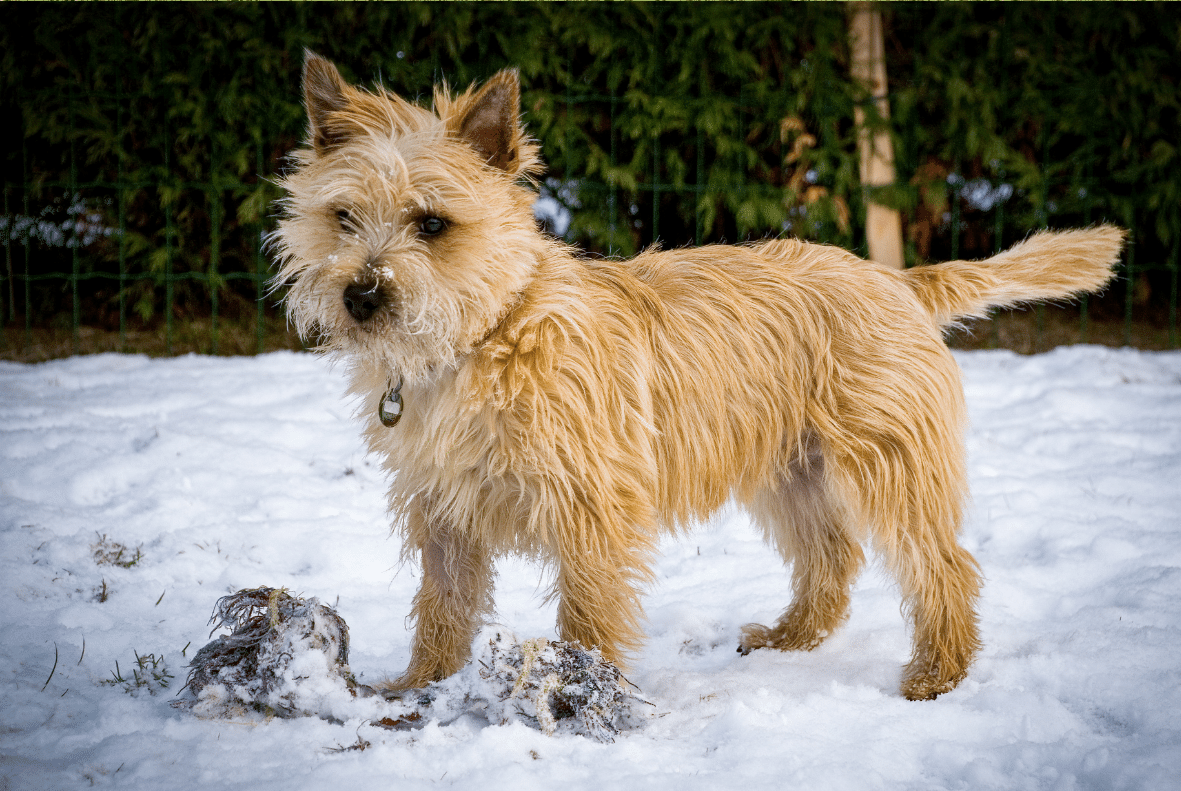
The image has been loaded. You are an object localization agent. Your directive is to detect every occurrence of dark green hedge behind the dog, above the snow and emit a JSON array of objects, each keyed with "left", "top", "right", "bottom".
[{"left": 0, "top": 2, "right": 1181, "bottom": 360}]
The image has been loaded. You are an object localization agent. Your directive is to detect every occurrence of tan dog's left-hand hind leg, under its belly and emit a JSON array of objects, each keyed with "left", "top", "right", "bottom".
[{"left": 738, "top": 446, "right": 864, "bottom": 654}]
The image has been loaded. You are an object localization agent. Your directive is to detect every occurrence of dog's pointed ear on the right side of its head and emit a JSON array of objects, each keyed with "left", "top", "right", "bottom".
[{"left": 448, "top": 68, "right": 523, "bottom": 174}]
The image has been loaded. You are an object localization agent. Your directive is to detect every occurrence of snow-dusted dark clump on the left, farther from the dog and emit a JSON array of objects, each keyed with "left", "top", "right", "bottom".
[{"left": 182, "top": 588, "right": 357, "bottom": 718}]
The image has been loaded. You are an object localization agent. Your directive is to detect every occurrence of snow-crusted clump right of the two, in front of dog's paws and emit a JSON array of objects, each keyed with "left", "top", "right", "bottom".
[{"left": 377, "top": 626, "right": 651, "bottom": 741}]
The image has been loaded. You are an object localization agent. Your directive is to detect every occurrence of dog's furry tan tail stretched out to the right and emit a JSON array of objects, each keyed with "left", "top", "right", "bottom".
[{"left": 903, "top": 225, "right": 1124, "bottom": 326}]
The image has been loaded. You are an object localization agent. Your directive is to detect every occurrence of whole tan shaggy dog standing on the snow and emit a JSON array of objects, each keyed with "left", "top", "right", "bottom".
[{"left": 275, "top": 53, "right": 1123, "bottom": 699}]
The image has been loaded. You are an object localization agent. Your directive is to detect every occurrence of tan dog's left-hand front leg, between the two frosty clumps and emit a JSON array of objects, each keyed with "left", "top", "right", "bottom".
[{"left": 385, "top": 506, "right": 492, "bottom": 689}]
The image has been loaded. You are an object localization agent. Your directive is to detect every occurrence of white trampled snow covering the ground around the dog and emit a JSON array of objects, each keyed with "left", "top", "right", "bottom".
[{"left": 0, "top": 347, "right": 1181, "bottom": 791}]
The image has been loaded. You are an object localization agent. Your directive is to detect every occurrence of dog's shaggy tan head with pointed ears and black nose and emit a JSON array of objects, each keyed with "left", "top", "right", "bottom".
[{"left": 274, "top": 52, "right": 541, "bottom": 380}]
